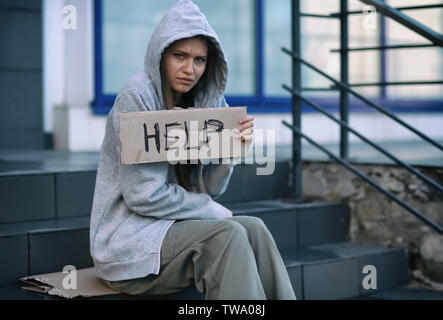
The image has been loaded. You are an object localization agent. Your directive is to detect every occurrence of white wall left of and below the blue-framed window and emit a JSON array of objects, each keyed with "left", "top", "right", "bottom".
[{"left": 43, "top": 0, "right": 443, "bottom": 151}]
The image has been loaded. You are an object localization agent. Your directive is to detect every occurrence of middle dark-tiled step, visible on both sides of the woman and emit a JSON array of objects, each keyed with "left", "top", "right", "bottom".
[{"left": 0, "top": 200, "right": 349, "bottom": 285}]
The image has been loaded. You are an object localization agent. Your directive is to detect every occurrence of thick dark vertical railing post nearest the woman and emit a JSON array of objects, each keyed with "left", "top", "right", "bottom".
[{"left": 291, "top": 0, "right": 303, "bottom": 201}]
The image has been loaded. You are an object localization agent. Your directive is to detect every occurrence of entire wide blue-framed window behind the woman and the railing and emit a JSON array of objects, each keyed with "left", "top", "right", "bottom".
[{"left": 93, "top": 0, "right": 443, "bottom": 114}]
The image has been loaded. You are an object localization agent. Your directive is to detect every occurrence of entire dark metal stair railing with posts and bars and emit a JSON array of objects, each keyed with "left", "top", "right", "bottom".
[{"left": 282, "top": 0, "right": 443, "bottom": 234}]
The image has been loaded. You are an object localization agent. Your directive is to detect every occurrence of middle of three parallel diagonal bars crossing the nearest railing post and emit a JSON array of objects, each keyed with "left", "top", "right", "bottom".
[{"left": 282, "top": 85, "right": 443, "bottom": 192}]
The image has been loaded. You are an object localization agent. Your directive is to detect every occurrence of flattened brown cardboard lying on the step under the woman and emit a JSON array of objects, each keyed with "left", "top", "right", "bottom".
[{"left": 19, "top": 267, "right": 120, "bottom": 299}]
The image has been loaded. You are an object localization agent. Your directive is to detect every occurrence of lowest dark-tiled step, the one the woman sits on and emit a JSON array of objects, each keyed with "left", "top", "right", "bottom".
[{"left": 0, "top": 242, "right": 408, "bottom": 300}]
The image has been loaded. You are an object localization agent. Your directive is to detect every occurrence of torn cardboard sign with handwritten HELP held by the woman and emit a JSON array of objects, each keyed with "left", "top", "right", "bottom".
[{"left": 119, "top": 107, "right": 250, "bottom": 164}]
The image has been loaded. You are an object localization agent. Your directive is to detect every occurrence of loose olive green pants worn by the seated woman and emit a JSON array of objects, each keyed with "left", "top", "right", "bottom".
[{"left": 105, "top": 216, "right": 296, "bottom": 300}]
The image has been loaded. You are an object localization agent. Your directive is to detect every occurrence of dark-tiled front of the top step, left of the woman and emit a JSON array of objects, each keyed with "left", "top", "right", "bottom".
[{"left": 0, "top": 171, "right": 97, "bottom": 223}]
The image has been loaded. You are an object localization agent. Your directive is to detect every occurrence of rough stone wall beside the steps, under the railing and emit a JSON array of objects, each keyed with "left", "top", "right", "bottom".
[{"left": 303, "top": 162, "right": 443, "bottom": 290}]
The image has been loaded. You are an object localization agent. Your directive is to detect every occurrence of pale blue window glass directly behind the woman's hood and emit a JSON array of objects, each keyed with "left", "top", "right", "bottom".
[{"left": 102, "top": 0, "right": 255, "bottom": 95}]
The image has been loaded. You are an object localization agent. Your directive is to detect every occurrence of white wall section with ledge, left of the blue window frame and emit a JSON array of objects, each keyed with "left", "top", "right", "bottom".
[{"left": 43, "top": 0, "right": 106, "bottom": 151}]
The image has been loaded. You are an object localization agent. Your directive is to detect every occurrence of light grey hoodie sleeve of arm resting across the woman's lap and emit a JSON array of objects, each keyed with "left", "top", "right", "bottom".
[{"left": 112, "top": 91, "right": 229, "bottom": 220}]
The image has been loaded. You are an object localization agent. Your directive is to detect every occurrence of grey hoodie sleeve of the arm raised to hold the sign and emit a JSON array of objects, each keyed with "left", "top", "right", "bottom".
[{"left": 203, "top": 95, "right": 241, "bottom": 199}]
